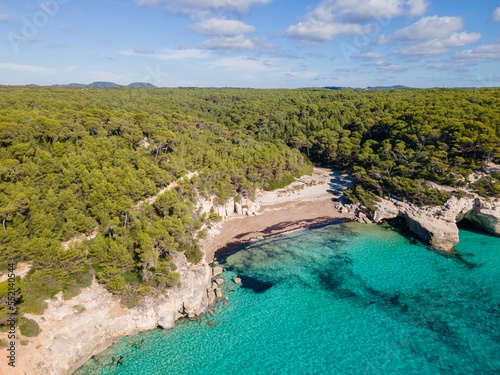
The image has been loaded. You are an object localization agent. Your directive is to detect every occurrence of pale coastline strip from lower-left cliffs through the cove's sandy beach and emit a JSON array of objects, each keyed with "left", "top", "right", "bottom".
[{"left": 0, "top": 168, "right": 354, "bottom": 375}]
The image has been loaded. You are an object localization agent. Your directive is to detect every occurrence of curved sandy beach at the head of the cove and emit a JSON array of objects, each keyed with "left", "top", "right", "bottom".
[{"left": 202, "top": 168, "right": 354, "bottom": 263}]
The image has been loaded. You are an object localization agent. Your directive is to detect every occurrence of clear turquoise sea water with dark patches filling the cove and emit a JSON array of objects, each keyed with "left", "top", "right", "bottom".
[{"left": 76, "top": 223, "right": 500, "bottom": 375}]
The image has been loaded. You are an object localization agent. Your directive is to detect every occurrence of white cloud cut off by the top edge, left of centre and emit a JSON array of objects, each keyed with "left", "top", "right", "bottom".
[{"left": 134, "top": 0, "right": 273, "bottom": 13}]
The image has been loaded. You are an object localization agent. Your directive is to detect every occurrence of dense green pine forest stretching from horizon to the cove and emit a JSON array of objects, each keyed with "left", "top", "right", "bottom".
[{"left": 0, "top": 87, "right": 500, "bottom": 336}]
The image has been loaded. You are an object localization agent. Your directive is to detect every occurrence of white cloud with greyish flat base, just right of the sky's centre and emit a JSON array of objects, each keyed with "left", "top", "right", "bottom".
[{"left": 286, "top": 21, "right": 366, "bottom": 44}]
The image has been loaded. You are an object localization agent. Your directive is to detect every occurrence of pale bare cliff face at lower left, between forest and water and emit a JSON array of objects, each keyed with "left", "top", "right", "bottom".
[{"left": 9, "top": 253, "right": 211, "bottom": 375}]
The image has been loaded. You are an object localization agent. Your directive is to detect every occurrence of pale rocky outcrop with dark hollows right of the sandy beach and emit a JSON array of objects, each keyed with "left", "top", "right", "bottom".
[{"left": 343, "top": 195, "right": 500, "bottom": 250}]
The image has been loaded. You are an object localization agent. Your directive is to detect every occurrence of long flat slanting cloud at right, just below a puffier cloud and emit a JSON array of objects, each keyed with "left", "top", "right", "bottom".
[{"left": 395, "top": 32, "right": 481, "bottom": 56}]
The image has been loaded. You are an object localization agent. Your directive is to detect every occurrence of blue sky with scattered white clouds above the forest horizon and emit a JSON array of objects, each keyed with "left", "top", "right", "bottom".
[{"left": 0, "top": 0, "right": 500, "bottom": 88}]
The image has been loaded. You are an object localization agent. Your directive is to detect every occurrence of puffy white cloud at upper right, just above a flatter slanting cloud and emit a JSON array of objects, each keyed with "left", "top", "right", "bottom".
[{"left": 394, "top": 16, "right": 464, "bottom": 41}]
